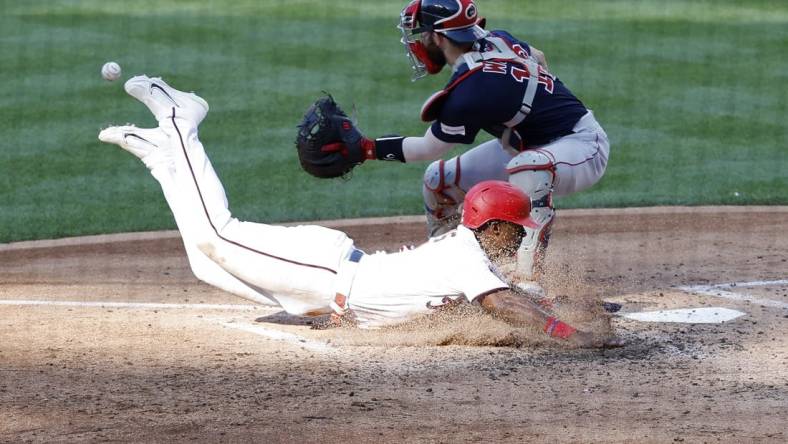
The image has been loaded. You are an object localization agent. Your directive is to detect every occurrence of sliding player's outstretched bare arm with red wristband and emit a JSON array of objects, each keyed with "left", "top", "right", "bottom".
[{"left": 478, "top": 290, "right": 623, "bottom": 347}]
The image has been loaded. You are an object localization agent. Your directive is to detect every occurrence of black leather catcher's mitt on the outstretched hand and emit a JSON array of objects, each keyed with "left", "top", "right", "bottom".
[{"left": 295, "top": 95, "right": 364, "bottom": 178}]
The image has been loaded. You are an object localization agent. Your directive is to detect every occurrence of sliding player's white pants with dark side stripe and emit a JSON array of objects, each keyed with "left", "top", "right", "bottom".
[{"left": 152, "top": 116, "right": 357, "bottom": 315}]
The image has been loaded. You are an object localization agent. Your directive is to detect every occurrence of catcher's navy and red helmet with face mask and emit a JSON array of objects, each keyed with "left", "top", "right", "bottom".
[{"left": 398, "top": 0, "right": 487, "bottom": 81}]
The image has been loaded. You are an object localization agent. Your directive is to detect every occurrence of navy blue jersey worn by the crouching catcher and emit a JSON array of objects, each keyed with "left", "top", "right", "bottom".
[{"left": 432, "top": 31, "right": 587, "bottom": 146}]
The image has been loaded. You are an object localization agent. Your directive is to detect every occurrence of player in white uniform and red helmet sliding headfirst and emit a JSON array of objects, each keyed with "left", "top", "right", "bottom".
[{"left": 99, "top": 76, "right": 619, "bottom": 347}]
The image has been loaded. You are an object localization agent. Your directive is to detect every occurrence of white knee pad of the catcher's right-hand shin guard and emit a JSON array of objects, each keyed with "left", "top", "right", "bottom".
[{"left": 506, "top": 150, "right": 555, "bottom": 201}]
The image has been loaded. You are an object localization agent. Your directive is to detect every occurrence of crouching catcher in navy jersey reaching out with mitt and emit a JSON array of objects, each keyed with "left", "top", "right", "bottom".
[{"left": 298, "top": 0, "right": 610, "bottom": 298}]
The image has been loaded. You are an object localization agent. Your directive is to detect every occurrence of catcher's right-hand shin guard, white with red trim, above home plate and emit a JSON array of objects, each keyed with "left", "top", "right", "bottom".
[{"left": 506, "top": 150, "right": 555, "bottom": 280}]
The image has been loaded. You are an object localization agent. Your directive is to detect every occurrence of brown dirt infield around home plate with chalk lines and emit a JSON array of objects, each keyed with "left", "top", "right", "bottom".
[{"left": 0, "top": 207, "right": 788, "bottom": 443}]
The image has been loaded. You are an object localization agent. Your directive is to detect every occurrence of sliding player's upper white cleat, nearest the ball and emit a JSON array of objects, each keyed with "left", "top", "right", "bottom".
[{"left": 124, "top": 75, "right": 208, "bottom": 125}]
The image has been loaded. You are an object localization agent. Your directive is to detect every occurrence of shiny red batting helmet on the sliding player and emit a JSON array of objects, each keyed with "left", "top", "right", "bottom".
[{"left": 462, "top": 180, "right": 539, "bottom": 230}]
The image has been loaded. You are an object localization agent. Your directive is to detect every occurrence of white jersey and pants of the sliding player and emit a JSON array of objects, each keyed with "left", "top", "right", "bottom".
[{"left": 152, "top": 117, "right": 509, "bottom": 327}]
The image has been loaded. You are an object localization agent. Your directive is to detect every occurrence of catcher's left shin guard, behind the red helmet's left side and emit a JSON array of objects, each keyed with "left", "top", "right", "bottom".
[{"left": 423, "top": 157, "right": 465, "bottom": 237}]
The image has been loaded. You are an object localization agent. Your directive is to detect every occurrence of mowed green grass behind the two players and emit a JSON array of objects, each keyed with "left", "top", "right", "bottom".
[{"left": 0, "top": 0, "right": 788, "bottom": 242}]
